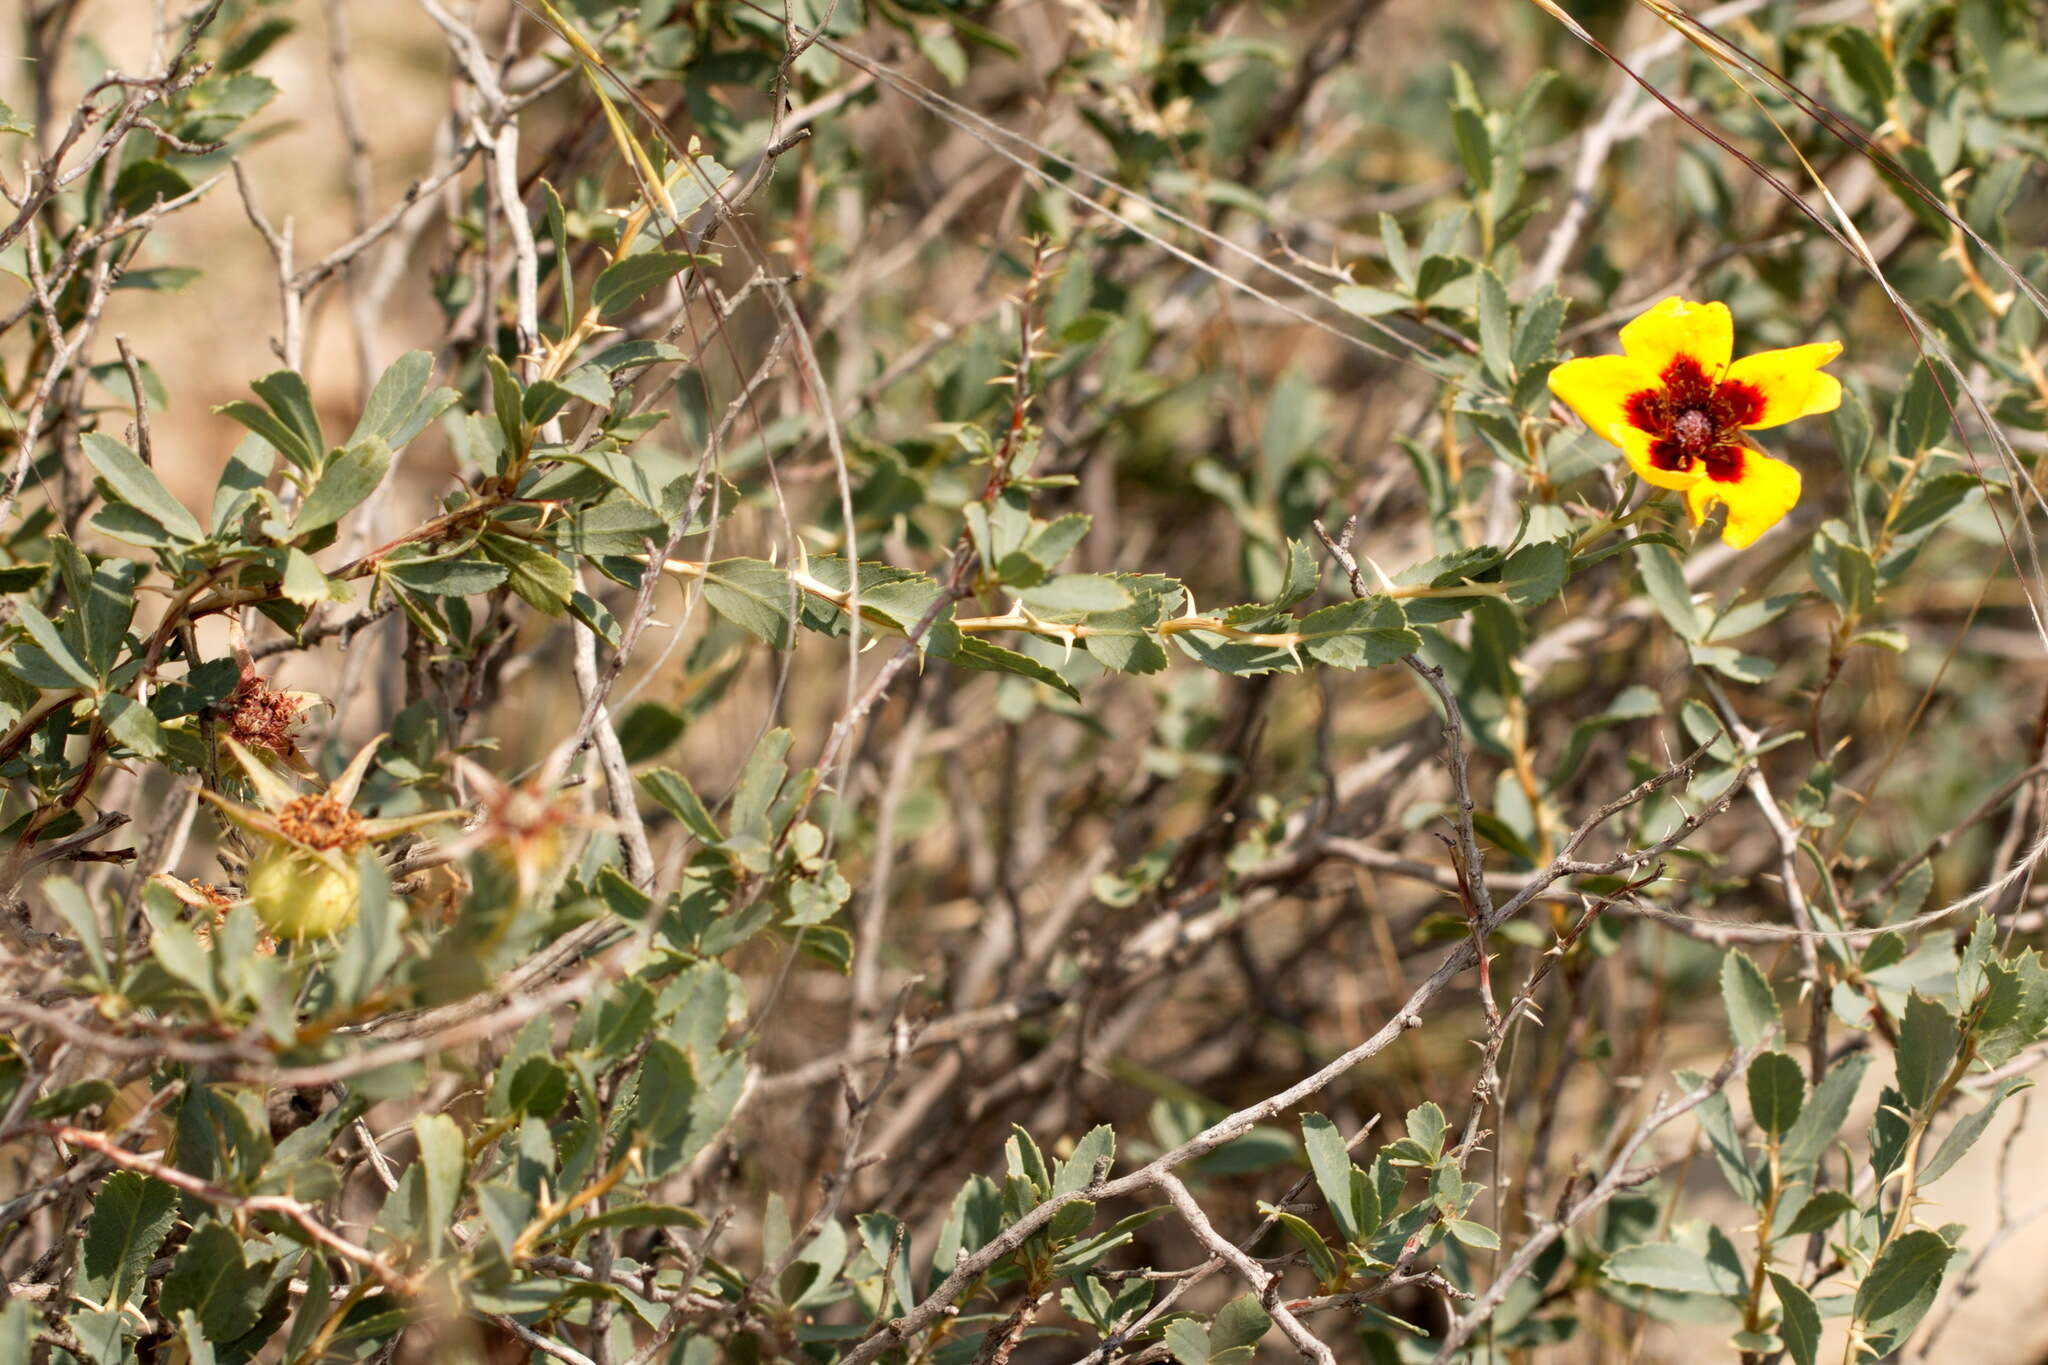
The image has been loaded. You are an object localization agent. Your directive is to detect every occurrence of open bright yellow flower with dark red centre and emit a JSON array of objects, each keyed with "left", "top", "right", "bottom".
[{"left": 1550, "top": 299, "right": 1841, "bottom": 548}]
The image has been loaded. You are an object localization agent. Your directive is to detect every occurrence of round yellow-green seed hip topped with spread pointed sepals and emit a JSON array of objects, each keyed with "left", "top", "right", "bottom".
[{"left": 201, "top": 735, "right": 463, "bottom": 939}]
